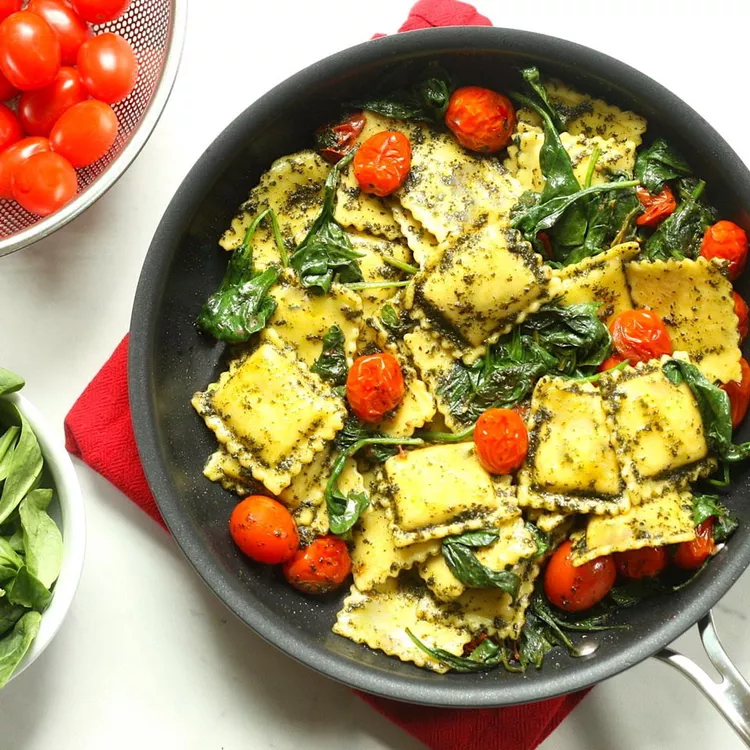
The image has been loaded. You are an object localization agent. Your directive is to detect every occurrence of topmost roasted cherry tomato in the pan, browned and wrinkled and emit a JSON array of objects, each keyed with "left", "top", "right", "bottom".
[{"left": 445, "top": 86, "right": 516, "bottom": 154}]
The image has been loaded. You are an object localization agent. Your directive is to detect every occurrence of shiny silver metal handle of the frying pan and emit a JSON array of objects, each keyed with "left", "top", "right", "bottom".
[{"left": 655, "top": 611, "right": 750, "bottom": 747}]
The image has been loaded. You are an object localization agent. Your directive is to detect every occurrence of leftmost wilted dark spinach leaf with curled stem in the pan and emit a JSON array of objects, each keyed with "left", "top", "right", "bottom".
[{"left": 197, "top": 208, "right": 283, "bottom": 344}]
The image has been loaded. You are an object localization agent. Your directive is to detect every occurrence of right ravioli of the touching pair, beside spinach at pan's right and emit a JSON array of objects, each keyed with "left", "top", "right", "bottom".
[{"left": 599, "top": 357, "right": 715, "bottom": 504}]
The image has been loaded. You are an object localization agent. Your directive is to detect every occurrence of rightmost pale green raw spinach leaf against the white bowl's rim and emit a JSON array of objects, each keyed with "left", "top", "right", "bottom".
[{"left": 18, "top": 490, "right": 63, "bottom": 588}]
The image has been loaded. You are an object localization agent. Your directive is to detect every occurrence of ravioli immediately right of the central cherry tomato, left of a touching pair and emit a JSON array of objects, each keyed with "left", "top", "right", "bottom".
[{"left": 518, "top": 376, "right": 630, "bottom": 513}]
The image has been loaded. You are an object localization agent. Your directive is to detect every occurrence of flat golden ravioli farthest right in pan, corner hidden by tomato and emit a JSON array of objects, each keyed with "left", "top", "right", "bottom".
[{"left": 626, "top": 258, "right": 742, "bottom": 383}]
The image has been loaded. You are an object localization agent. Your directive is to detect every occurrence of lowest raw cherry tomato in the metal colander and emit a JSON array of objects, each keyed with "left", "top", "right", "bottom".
[{"left": 13, "top": 151, "right": 78, "bottom": 216}]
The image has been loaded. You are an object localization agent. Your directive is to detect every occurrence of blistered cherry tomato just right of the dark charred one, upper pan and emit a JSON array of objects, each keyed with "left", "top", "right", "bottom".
[{"left": 354, "top": 130, "right": 411, "bottom": 197}]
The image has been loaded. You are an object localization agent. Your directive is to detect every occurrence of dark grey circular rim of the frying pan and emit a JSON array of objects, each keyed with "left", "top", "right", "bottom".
[{"left": 128, "top": 26, "right": 750, "bottom": 708}]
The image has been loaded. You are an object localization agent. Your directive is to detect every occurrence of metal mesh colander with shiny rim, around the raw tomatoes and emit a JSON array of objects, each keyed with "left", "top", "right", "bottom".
[{"left": 0, "top": 0, "right": 187, "bottom": 255}]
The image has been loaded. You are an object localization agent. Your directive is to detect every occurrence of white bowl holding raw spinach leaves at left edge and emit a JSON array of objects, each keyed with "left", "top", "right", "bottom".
[{"left": 7, "top": 393, "right": 86, "bottom": 680}]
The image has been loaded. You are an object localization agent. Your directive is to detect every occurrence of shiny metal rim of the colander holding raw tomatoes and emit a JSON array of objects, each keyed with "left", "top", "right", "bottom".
[{"left": 0, "top": 0, "right": 188, "bottom": 257}]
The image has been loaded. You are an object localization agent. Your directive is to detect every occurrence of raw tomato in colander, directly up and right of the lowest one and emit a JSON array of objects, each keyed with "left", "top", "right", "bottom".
[{"left": 49, "top": 99, "right": 118, "bottom": 167}]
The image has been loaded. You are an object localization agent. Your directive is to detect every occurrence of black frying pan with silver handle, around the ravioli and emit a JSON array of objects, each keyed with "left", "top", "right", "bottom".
[{"left": 129, "top": 27, "right": 750, "bottom": 740}]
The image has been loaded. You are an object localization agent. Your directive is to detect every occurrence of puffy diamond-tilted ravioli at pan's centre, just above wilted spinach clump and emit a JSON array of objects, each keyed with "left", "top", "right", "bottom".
[{"left": 404, "top": 224, "right": 556, "bottom": 358}]
